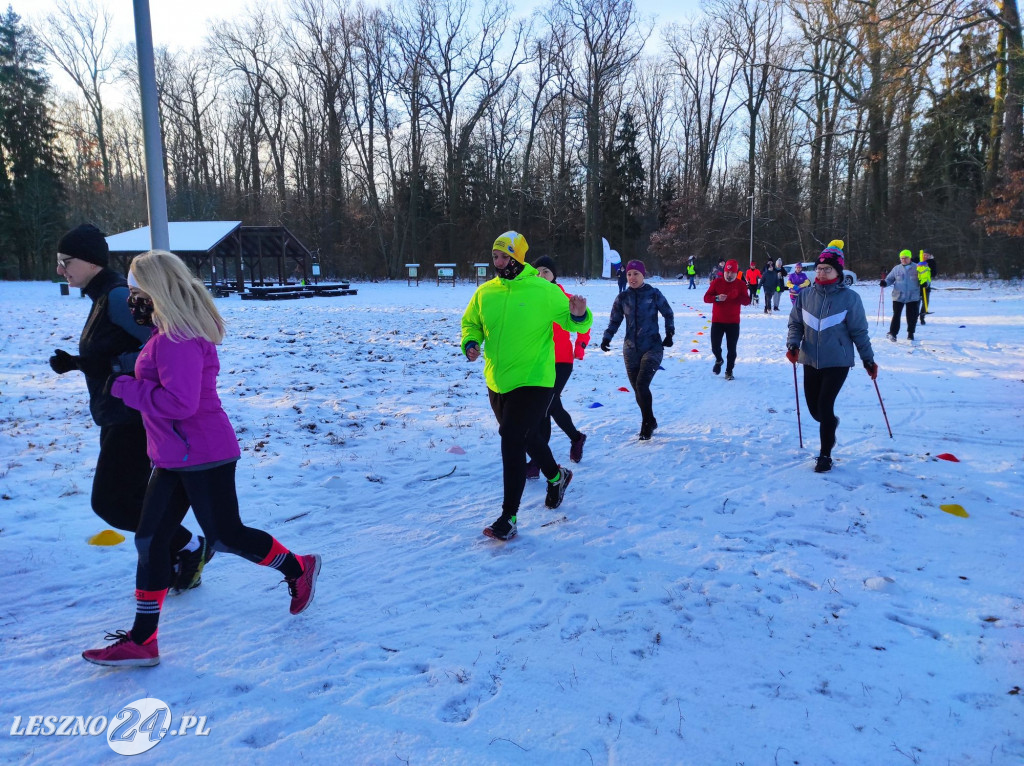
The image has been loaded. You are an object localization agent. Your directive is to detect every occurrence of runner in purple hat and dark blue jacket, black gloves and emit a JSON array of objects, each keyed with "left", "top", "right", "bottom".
[{"left": 601, "top": 260, "right": 676, "bottom": 440}]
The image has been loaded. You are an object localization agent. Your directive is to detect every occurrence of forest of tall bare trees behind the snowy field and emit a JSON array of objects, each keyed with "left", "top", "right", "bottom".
[{"left": 0, "top": 0, "right": 1024, "bottom": 279}]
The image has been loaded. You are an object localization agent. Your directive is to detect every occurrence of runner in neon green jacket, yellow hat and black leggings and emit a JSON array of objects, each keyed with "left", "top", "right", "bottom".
[{"left": 462, "top": 231, "right": 594, "bottom": 540}]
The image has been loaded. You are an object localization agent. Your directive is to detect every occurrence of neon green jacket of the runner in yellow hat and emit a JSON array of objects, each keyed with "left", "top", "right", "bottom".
[{"left": 462, "top": 264, "right": 594, "bottom": 393}]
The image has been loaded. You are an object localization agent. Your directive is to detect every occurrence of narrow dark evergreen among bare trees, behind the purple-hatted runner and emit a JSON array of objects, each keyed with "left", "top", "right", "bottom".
[{"left": 601, "top": 109, "right": 647, "bottom": 262}]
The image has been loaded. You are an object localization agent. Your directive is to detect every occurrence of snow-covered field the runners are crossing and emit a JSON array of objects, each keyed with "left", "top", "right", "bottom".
[{"left": 0, "top": 280, "right": 1024, "bottom": 766}]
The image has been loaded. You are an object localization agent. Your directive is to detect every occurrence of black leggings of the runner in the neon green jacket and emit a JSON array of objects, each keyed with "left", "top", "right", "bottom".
[{"left": 487, "top": 386, "right": 558, "bottom": 516}]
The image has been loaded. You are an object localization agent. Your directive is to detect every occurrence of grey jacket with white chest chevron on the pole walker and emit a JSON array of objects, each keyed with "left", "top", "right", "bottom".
[{"left": 785, "top": 283, "right": 874, "bottom": 370}]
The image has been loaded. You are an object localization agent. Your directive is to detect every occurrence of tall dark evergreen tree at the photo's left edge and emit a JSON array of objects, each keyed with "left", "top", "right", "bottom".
[{"left": 0, "top": 5, "right": 67, "bottom": 279}]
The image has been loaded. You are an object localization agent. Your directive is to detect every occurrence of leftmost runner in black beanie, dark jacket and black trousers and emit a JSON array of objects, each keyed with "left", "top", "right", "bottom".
[{"left": 49, "top": 223, "right": 208, "bottom": 590}]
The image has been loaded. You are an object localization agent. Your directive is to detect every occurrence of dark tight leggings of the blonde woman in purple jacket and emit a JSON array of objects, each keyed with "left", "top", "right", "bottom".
[{"left": 135, "top": 461, "right": 273, "bottom": 591}]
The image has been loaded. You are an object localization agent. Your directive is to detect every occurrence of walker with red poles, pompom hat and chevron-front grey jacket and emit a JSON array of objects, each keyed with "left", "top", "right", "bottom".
[{"left": 785, "top": 246, "right": 879, "bottom": 473}]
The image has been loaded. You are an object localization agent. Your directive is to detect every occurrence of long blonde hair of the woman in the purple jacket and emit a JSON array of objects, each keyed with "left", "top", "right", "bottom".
[{"left": 131, "top": 250, "right": 224, "bottom": 343}]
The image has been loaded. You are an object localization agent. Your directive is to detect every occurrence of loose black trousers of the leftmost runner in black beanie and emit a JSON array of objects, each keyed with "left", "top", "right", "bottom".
[{"left": 92, "top": 418, "right": 191, "bottom": 554}]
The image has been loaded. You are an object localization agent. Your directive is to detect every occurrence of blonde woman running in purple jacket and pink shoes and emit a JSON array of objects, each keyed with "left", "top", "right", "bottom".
[{"left": 82, "top": 250, "right": 321, "bottom": 666}]
